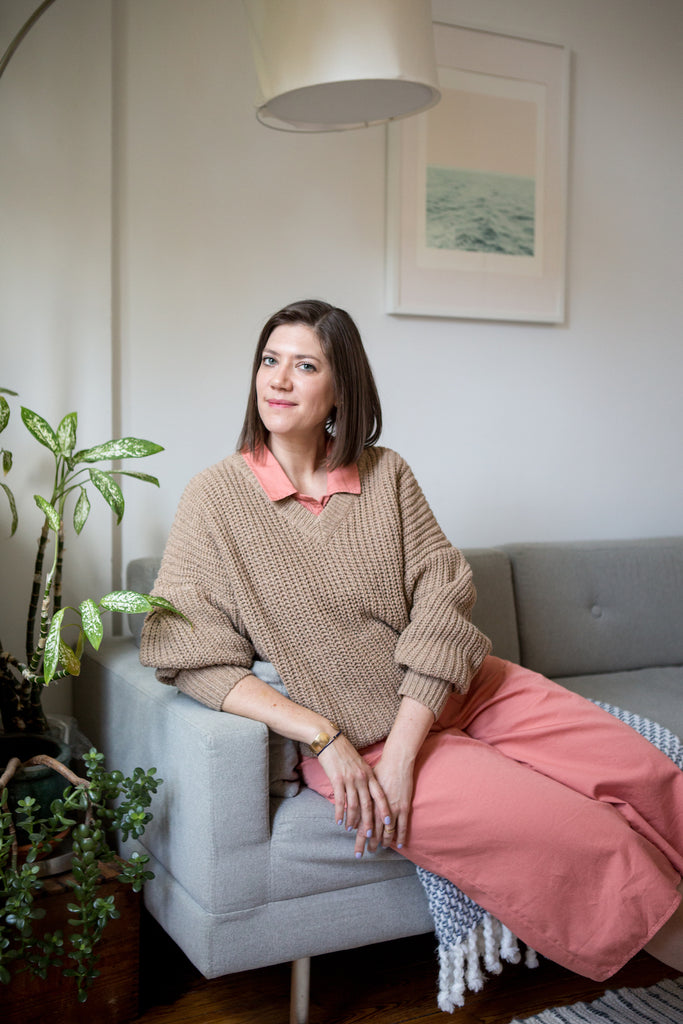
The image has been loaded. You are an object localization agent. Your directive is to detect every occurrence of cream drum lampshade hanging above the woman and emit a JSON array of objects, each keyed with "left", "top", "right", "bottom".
[{"left": 244, "top": 0, "right": 440, "bottom": 132}]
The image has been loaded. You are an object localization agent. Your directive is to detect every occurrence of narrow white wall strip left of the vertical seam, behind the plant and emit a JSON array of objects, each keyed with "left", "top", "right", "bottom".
[{"left": 0, "top": 0, "right": 112, "bottom": 710}]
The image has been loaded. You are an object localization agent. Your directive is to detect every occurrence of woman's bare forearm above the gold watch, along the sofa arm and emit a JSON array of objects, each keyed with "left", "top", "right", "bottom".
[{"left": 221, "top": 674, "right": 337, "bottom": 743}]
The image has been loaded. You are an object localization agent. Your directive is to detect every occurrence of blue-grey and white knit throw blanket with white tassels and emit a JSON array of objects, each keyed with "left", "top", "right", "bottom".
[{"left": 418, "top": 700, "right": 683, "bottom": 1014}]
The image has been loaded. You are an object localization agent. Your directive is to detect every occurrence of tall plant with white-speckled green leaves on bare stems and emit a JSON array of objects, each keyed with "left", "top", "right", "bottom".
[{"left": 0, "top": 388, "right": 181, "bottom": 737}]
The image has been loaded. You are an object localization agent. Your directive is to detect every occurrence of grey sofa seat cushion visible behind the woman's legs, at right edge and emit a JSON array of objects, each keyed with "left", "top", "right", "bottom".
[{"left": 555, "top": 666, "right": 683, "bottom": 736}]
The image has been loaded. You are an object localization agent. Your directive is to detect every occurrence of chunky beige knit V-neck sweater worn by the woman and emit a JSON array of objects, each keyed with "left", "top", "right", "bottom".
[{"left": 140, "top": 447, "right": 490, "bottom": 748}]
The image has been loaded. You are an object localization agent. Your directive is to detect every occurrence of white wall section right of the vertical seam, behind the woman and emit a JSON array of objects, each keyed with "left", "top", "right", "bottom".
[{"left": 116, "top": 0, "right": 683, "bottom": 569}]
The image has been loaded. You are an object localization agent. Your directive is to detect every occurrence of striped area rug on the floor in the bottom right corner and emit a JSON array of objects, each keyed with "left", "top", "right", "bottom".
[{"left": 510, "top": 978, "right": 683, "bottom": 1024}]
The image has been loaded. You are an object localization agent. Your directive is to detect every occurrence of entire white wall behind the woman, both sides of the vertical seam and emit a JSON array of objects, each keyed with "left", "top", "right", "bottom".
[{"left": 0, "top": 0, "right": 683, "bottom": 720}]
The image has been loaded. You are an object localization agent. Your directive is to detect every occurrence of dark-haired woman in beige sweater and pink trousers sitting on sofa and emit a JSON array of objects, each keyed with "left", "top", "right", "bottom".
[{"left": 141, "top": 301, "right": 683, "bottom": 980}]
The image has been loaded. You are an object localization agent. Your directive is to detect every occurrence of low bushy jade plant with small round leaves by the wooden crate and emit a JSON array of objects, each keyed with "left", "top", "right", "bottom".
[{"left": 0, "top": 749, "right": 158, "bottom": 1002}]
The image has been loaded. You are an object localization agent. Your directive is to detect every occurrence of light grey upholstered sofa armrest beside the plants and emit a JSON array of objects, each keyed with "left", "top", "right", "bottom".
[{"left": 74, "top": 638, "right": 270, "bottom": 912}]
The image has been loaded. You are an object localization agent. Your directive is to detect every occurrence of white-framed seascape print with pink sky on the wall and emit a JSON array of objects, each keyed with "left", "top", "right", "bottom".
[{"left": 387, "top": 23, "right": 569, "bottom": 323}]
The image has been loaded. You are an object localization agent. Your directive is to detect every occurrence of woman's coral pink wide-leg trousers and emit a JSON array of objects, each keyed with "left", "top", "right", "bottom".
[{"left": 302, "top": 656, "right": 683, "bottom": 980}]
